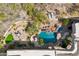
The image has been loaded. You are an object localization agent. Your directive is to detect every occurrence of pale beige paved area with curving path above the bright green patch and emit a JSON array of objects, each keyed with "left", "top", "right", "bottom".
[{"left": 4, "top": 21, "right": 27, "bottom": 41}]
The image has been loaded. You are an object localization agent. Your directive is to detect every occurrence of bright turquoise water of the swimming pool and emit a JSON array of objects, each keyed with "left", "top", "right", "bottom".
[{"left": 39, "top": 31, "right": 57, "bottom": 43}]
